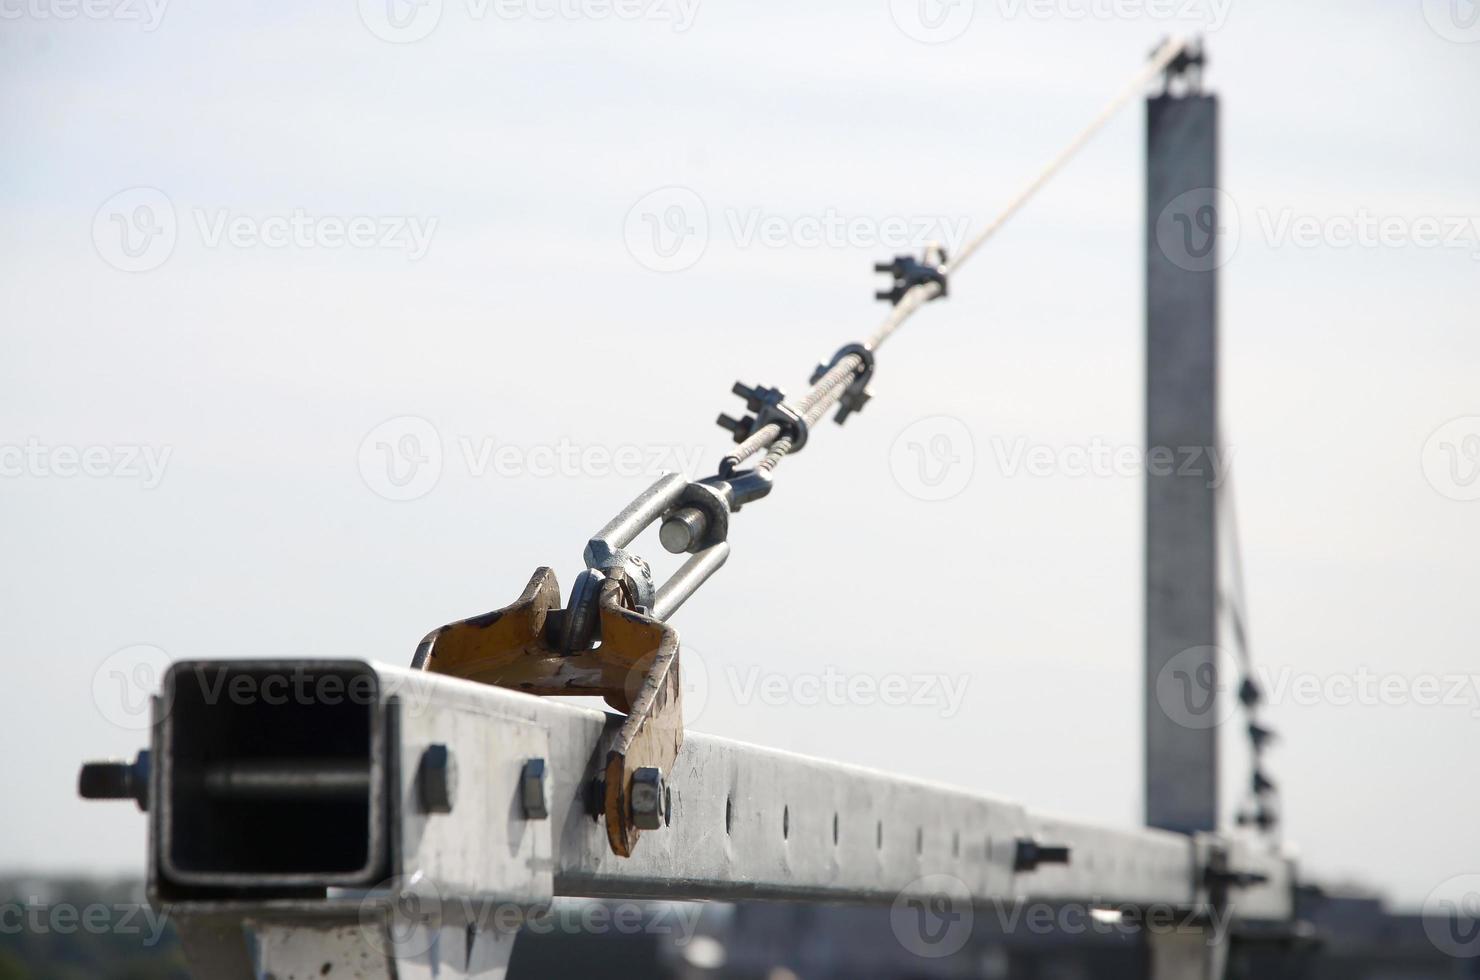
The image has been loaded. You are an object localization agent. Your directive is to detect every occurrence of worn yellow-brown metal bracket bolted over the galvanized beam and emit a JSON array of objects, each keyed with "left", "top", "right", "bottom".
[{"left": 414, "top": 568, "right": 684, "bottom": 857}]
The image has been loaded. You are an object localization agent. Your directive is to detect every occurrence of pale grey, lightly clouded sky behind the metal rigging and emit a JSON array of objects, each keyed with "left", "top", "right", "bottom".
[{"left": 0, "top": 0, "right": 1480, "bottom": 903}]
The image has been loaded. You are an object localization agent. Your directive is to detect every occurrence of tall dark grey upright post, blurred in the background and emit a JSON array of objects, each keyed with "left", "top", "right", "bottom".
[{"left": 1146, "top": 93, "right": 1233, "bottom": 833}]
